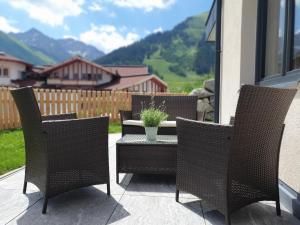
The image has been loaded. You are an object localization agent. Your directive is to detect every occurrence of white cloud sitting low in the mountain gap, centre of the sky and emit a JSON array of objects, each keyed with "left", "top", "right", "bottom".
[{"left": 80, "top": 24, "right": 140, "bottom": 53}]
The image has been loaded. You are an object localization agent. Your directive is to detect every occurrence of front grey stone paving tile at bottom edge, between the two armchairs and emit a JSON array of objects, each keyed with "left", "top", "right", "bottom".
[{"left": 108, "top": 195, "right": 205, "bottom": 225}]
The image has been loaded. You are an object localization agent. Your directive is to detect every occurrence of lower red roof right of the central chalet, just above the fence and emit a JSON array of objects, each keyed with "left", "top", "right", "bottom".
[{"left": 104, "top": 75, "right": 168, "bottom": 90}]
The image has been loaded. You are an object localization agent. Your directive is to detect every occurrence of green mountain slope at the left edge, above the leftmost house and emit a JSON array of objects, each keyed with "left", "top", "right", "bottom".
[{"left": 0, "top": 31, "right": 54, "bottom": 65}]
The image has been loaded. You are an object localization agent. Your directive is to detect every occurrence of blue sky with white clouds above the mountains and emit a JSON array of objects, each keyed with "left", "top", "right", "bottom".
[{"left": 0, "top": 0, "right": 212, "bottom": 53}]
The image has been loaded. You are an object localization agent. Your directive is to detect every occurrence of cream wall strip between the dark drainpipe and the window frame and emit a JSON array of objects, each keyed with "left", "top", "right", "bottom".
[{"left": 220, "top": 0, "right": 257, "bottom": 123}]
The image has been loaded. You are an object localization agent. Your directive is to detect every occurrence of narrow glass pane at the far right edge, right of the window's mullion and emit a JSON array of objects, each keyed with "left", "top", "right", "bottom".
[{"left": 292, "top": 0, "right": 300, "bottom": 69}]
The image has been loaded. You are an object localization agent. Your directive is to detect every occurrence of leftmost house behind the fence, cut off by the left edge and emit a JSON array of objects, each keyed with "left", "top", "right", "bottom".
[{"left": 0, "top": 52, "right": 32, "bottom": 86}]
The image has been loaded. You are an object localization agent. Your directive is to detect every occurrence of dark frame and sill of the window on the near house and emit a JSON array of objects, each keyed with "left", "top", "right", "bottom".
[{"left": 255, "top": 0, "right": 300, "bottom": 85}]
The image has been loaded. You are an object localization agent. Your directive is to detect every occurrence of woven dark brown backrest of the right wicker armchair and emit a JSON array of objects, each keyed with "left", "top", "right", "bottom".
[{"left": 228, "top": 85, "right": 296, "bottom": 201}]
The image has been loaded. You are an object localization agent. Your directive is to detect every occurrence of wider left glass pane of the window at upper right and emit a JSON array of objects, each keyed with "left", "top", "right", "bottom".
[{"left": 265, "top": 0, "right": 286, "bottom": 76}]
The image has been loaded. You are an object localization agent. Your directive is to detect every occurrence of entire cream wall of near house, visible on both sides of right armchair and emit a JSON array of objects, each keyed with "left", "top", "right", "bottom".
[{"left": 220, "top": 0, "right": 300, "bottom": 193}]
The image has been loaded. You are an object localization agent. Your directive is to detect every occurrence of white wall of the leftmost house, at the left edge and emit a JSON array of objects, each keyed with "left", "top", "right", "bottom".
[{"left": 0, "top": 61, "right": 26, "bottom": 86}]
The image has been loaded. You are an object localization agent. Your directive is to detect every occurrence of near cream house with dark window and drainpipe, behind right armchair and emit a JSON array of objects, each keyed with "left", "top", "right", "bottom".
[{"left": 206, "top": 0, "right": 300, "bottom": 218}]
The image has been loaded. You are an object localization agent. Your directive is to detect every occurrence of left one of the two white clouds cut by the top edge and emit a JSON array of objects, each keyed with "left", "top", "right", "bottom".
[{"left": 9, "top": 0, "right": 85, "bottom": 27}]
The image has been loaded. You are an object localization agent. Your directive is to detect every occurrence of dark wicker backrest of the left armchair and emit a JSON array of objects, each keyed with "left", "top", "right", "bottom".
[{"left": 11, "top": 87, "right": 42, "bottom": 151}]
